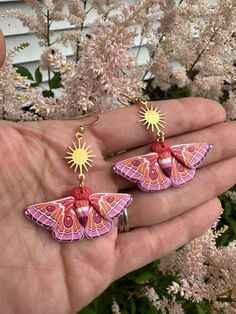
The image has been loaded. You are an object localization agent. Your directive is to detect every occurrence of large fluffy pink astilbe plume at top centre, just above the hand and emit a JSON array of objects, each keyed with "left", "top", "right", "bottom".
[{"left": 60, "top": 16, "right": 144, "bottom": 113}]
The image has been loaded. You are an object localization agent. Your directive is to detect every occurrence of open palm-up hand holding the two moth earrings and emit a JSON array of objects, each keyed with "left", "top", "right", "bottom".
[{"left": 0, "top": 98, "right": 236, "bottom": 314}]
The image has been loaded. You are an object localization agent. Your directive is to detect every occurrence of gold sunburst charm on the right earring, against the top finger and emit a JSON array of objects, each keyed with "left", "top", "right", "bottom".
[{"left": 139, "top": 104, "right": 165, "bottom": 134}]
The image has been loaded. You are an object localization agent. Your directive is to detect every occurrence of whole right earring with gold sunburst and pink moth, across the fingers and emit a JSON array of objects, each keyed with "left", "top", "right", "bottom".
[{"left": 113, "top": 98, "right": 212, "bottom": 192}]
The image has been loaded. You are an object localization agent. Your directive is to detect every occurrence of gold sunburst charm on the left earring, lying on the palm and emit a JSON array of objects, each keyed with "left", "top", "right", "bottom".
[{"left": 65, "top": 139, "right": 96, "bottom": 175}]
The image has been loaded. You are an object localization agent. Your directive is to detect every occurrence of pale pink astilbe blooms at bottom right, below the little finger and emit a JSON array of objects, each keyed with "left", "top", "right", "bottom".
[{"left": 160, "top": 224, "right": 236, "bottom": 309}]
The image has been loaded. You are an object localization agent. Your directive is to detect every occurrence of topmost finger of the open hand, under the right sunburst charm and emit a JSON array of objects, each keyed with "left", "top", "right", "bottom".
[{"left": 92, "top": 97, "right": 225, "bottom": 153}]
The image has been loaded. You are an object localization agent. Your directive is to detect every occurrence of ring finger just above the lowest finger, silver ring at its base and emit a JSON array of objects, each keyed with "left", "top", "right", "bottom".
[{"left": 128, "top": 157, "right": 236, "bottom": 227}]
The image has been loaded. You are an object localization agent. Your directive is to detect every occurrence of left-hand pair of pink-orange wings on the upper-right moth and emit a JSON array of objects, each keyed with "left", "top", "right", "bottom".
[{"left": 113, "top": 153, "right": 171, "bottom": 192}]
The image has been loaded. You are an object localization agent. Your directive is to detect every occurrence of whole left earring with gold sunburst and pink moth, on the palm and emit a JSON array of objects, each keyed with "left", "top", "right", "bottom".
[{"left": 25, "top": 121, "right": 132, "bottom": 242}]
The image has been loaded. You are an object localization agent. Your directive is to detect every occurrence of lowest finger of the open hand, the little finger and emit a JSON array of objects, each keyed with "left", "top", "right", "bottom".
[{"left": 114, "top": 198, "right": 222, "bottom": 279}]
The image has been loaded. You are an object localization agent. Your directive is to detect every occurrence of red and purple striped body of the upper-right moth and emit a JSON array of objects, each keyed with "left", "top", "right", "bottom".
[{"left": 150, "top": 141, "right": 171, "bottom": 177}]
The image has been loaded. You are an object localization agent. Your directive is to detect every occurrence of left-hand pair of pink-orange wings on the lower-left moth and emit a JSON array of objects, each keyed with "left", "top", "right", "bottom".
[{"left": 25, "top": 197, "right": 84, "bottom": 241}]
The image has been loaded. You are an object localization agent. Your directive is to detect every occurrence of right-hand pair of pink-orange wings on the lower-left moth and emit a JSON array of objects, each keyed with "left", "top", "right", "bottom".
[{"left": 85, "top": 193, "right": 132, "bottom": 238}]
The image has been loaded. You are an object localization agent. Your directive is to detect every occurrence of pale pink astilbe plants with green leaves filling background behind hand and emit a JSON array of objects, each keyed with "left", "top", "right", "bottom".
[{"left": 0, "top": 0, "right": 236, "bottom": 314}]
